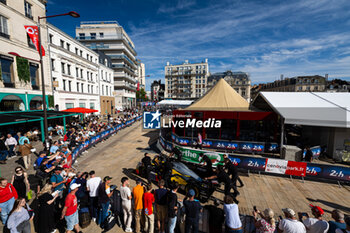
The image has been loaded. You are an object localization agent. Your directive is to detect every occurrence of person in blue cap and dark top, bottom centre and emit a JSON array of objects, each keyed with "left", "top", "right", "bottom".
[{"left": 183, "top": 189, "right": 203, "bottom": 233}]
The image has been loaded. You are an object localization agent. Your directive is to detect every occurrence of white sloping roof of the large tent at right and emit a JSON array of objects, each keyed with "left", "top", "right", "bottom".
[{"left": 253, "top": 92, "right": 350, "bottom": 128}]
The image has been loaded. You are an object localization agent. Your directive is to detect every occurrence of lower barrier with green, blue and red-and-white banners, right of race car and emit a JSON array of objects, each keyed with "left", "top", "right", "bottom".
[{"left": 159, "top": 135, "right": 350, "bottom": 182}]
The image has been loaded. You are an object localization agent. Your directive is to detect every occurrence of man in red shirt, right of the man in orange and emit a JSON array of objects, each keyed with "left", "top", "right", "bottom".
[{"left": 143, "top": 185, "right": 154, "bottom": 233}]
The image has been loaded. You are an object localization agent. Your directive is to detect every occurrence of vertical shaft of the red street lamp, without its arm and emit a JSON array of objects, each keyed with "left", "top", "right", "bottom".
[{"left": 38, "top": 16, "right": 49, "bottom": 149}]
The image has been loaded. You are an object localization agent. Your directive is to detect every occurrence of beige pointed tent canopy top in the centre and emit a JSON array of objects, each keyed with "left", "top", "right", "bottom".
[{"left": 185, "top": 78, "right": 249, "bottom": 111}]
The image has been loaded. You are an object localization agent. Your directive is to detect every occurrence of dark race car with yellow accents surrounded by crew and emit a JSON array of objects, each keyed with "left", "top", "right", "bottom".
[{"left": 136, "top": 156, "right": 218, "bottom": 202}]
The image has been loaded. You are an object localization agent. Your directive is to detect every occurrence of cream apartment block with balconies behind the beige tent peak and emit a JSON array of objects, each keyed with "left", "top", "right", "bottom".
[{"left": 164, "top": 59, "right": 209, "bottom": 99}]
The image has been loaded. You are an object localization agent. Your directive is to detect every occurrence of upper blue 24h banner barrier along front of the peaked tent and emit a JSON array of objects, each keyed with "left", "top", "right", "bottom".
[{"left": 171, "top": 133, "right": 279, "bottom": 154}]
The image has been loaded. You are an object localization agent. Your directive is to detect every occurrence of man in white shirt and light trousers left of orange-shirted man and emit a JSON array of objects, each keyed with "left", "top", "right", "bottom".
[{"left": 120, "top": 177, "right": 132, "bottom": 232}]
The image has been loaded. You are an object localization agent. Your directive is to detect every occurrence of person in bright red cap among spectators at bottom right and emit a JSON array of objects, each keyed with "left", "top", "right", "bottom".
[{"left": 298, "top": 204, "right": 329, "bottom": 233}]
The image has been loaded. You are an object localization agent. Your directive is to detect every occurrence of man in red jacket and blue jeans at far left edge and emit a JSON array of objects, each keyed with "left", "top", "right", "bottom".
[{"left": 0, "top": 178, "right": 18, "bottom": 225}]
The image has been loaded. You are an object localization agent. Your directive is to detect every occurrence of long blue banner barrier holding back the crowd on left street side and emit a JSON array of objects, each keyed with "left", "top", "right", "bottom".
[{"left": 67, "top": 115, "right": 142, "bottom": 166}]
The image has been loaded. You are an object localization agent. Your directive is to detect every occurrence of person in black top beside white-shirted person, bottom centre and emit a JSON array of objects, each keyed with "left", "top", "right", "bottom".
[{"left": 204, "top": 199, "right": 225, "bottom": 233}]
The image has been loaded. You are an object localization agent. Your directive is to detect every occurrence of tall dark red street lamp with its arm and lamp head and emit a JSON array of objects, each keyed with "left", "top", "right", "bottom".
[{"left": 38, "top": 11, "right": 80, "bottom": 149}]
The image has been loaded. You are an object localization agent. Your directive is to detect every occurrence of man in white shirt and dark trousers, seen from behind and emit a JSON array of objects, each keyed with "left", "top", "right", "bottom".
[{"left": 86, "top": 171, "right": 102, "bottom": 221}]
